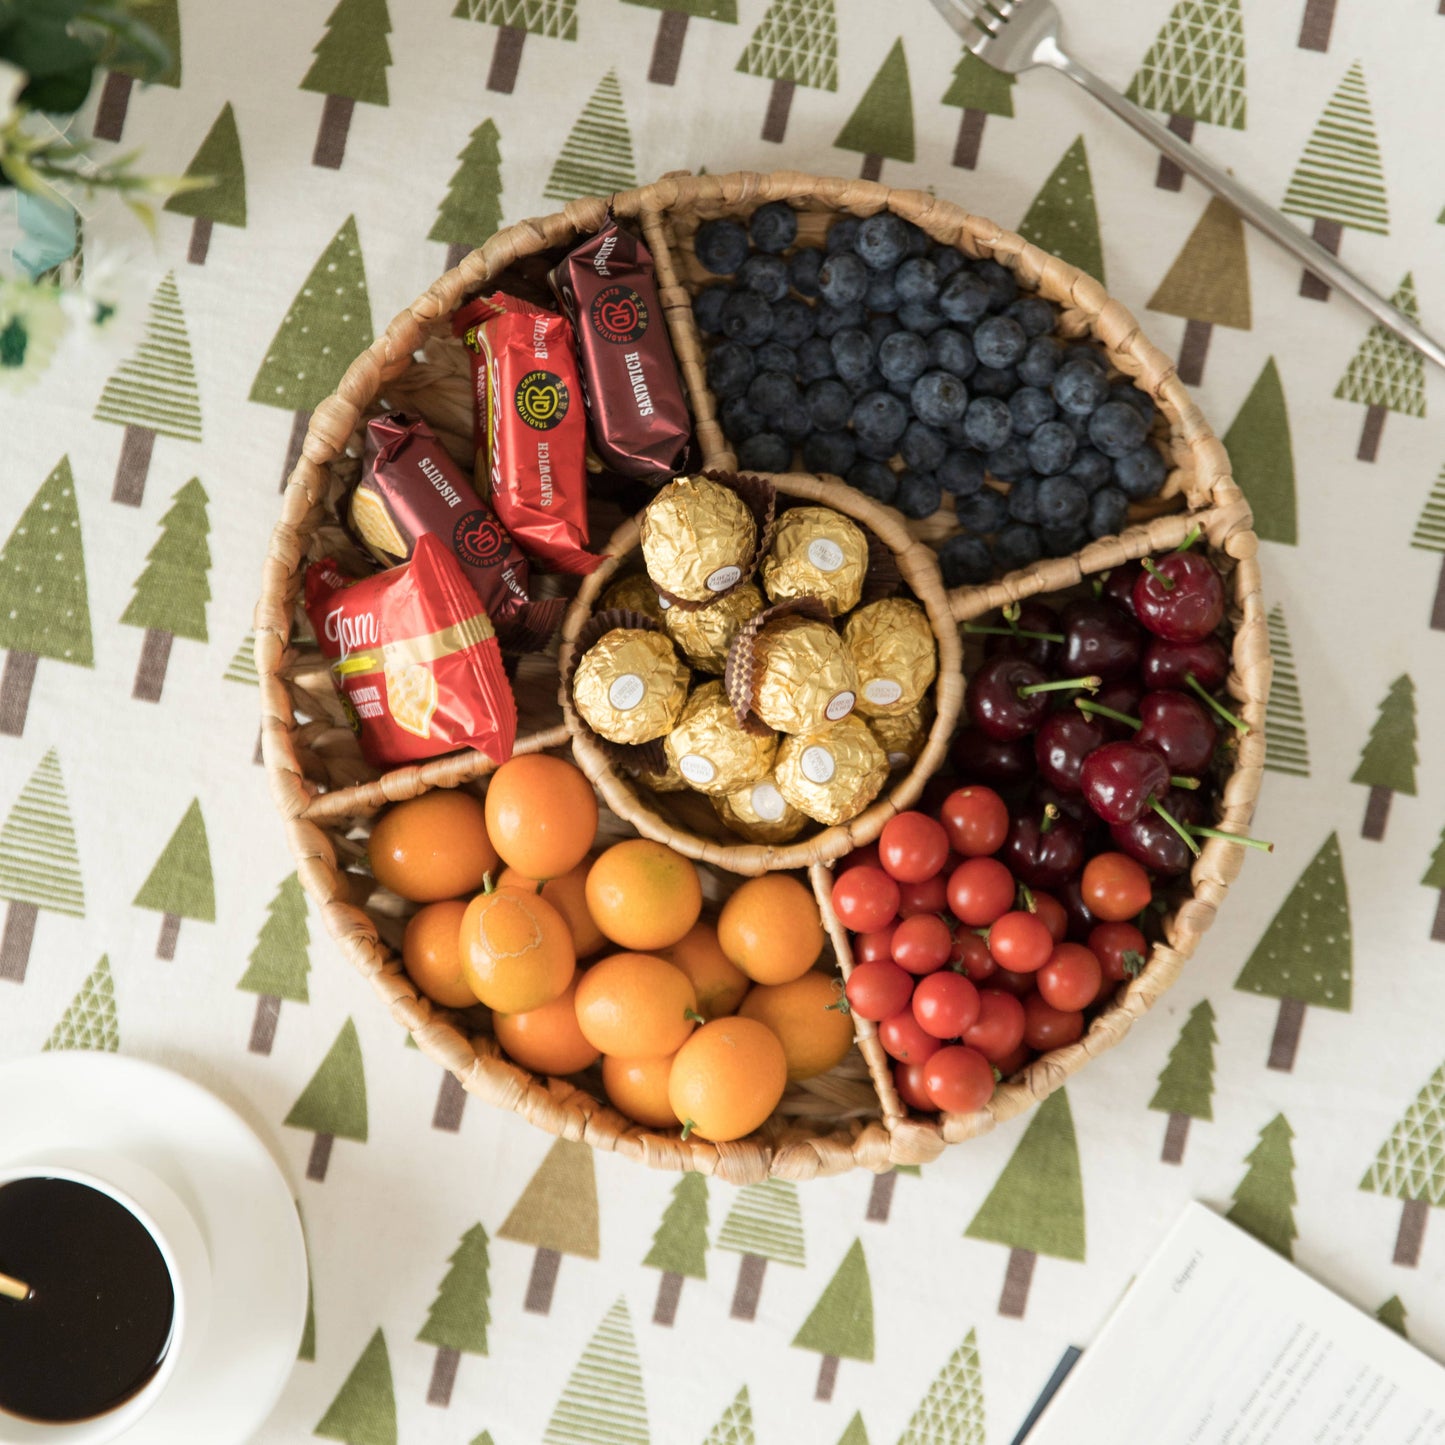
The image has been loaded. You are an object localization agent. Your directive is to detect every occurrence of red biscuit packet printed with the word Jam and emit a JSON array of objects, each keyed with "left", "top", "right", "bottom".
[{"left": 306, "top": 533, "right": 517, "bottom": 767}]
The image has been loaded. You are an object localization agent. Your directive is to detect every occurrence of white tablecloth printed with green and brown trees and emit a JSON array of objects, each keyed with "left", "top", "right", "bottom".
[{"left": 0, "top": 0, "right": 1445, "bottom": 1445}]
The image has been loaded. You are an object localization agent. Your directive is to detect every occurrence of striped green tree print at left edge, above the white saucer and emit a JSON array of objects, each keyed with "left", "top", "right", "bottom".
[{"left": 0, "top": 747, "right": 85, "bottom": 984}]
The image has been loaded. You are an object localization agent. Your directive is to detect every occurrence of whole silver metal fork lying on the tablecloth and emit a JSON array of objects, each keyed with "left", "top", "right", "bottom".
[{"left": 933, "top": 0, "right": 1445, "bottom": 367}]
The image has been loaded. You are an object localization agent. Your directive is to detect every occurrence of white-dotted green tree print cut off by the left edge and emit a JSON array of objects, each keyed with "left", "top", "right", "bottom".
[{"left": 0, "top": 457, "right": 95, "bottom": 737}]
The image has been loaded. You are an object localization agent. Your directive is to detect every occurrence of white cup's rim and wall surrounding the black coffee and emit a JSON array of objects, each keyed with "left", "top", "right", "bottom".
[{"left": 0, "top": 1150, "right": 211, "bottom": 1445}]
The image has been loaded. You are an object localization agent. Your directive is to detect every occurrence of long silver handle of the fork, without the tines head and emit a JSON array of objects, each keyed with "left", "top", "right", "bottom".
[{"left": 1033, "top": 39, "right": 1445, "bottom": 367}]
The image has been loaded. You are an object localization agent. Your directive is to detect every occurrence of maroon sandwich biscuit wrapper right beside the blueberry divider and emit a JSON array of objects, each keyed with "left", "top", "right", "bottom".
[{"left": 548, "top": 217, "right": 692, "bottom": 483}]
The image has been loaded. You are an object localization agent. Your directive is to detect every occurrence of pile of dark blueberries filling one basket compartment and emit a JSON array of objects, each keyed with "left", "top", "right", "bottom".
[{"left": 694, "top": 201, "right": 1168, "bottom": 587}]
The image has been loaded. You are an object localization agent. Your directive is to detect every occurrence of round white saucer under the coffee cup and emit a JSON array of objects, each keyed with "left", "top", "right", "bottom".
[{"left": 0, "top": 1051, "right": 306, "bottom": 1445}]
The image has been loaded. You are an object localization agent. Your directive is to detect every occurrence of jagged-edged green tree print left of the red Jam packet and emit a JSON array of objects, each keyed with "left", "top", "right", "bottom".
[{"left": 120, "top": 477, "right": 211, "bottom": 702}]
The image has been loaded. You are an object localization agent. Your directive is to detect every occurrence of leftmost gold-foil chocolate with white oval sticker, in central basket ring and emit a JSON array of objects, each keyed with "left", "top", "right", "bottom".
[{"left": 572, "top": 627, "right": 688, "bottom": 743}]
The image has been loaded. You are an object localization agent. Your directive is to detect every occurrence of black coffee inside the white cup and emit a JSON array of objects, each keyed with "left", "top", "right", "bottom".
[{"left": 0, "top": 1179, "right": 175, "bottom": 1422}]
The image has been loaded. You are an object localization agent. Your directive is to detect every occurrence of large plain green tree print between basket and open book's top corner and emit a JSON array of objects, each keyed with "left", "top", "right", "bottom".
[{"left": 964, "top": 1088, "right": 1084, "bottom": 1319}]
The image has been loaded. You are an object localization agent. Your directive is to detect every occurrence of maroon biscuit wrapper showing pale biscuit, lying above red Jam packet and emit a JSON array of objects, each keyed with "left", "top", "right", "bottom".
[{"left": 347, "top": 412, "right": 566, "bottom": 652}]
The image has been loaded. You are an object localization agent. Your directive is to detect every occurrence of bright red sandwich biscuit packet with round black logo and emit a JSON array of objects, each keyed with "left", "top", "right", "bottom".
[{"left": 452, "top": 292, "right": 601, "bottom": 575}]
